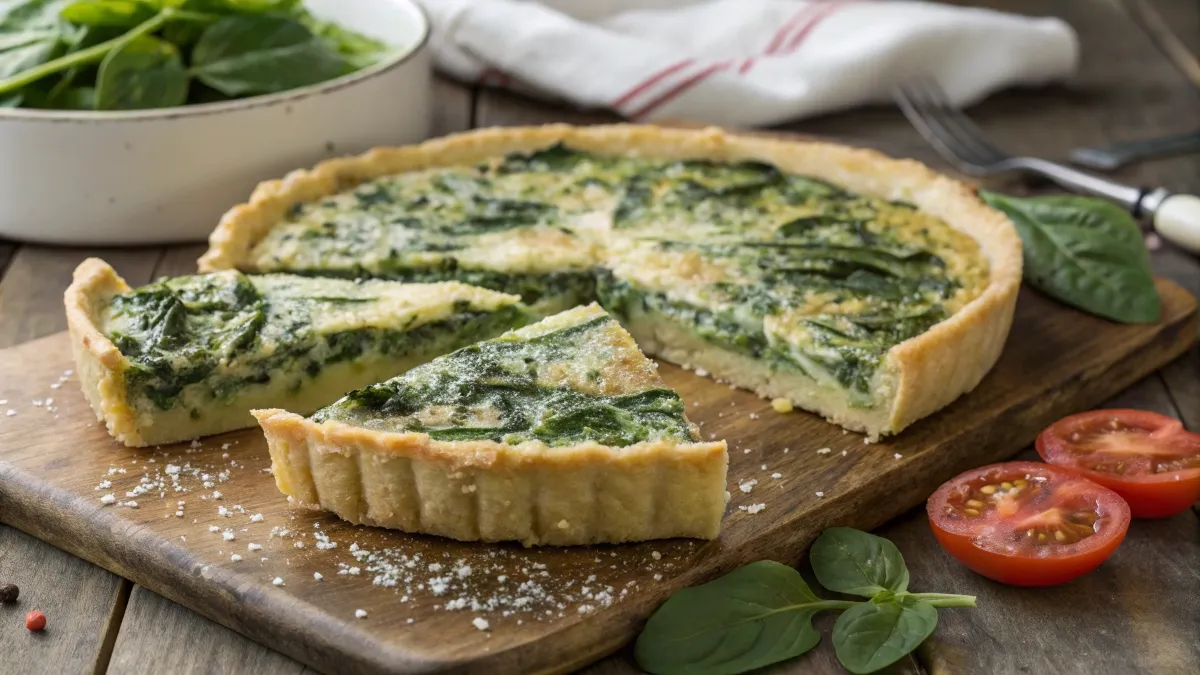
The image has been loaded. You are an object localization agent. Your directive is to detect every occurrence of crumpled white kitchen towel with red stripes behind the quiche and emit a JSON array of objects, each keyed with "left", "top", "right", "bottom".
[{"left": 422, "top": 0, "right": 1079, "bottom": 127}]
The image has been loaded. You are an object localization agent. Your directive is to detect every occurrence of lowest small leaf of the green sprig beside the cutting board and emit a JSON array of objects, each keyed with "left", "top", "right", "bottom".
[{"left": 833, "top": 598, "right": 937, "bottom": 674}]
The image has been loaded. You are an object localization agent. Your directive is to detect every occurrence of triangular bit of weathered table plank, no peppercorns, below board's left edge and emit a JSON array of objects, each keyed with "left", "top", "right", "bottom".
[{"left": 108, "top": 586, "right": 312, "bottom": 675}]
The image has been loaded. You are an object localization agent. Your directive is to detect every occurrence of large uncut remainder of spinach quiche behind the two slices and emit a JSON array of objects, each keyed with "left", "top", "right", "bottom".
[{"left": 200, "top": 125, "right": 1021, "bottom": 438}]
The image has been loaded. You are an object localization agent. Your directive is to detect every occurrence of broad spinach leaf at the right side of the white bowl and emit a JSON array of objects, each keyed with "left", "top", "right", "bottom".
[{"left": 192, "top": 14, "right": 354, "bottom": 96}]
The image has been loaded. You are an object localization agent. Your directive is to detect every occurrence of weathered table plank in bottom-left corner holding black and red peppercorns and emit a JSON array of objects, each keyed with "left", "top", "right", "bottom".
[{"left": 0, "top": 516, "right": 130, "bottom": 675}]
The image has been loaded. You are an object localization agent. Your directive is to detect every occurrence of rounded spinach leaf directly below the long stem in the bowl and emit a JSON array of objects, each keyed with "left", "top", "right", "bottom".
[{"left": 96, "top": 36, "right": 187, "bottom": 110}]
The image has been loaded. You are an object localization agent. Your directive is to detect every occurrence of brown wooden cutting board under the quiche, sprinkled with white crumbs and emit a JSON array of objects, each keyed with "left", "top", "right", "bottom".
[{"left": 0, "top": 280, "right": 1196, "bottom": 674}]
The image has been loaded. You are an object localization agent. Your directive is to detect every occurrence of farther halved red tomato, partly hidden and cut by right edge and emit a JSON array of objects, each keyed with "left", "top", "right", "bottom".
[{"left": 1037, "top": 410, "right": 1200, "bottom": 518}]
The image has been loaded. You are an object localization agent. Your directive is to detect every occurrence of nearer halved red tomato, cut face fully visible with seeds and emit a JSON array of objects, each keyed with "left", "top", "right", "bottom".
[{"left": 925, "top": 461, "right": 1129, "bottom": 586}]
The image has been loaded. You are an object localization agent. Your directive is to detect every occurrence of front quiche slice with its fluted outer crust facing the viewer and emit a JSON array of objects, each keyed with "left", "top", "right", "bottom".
[{"left": 254, "top": 304, "right": 728, "bottom": 545}]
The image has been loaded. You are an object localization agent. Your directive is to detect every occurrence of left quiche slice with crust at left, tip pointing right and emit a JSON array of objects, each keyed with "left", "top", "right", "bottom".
[{"left": 65, "top": 258, "right": 532, "bottom": 447}]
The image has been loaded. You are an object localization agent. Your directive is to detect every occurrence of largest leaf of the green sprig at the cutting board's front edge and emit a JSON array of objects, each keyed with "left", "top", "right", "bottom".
[{"left": 635, "top": 561, "right": 822, "bottom": 675}]
